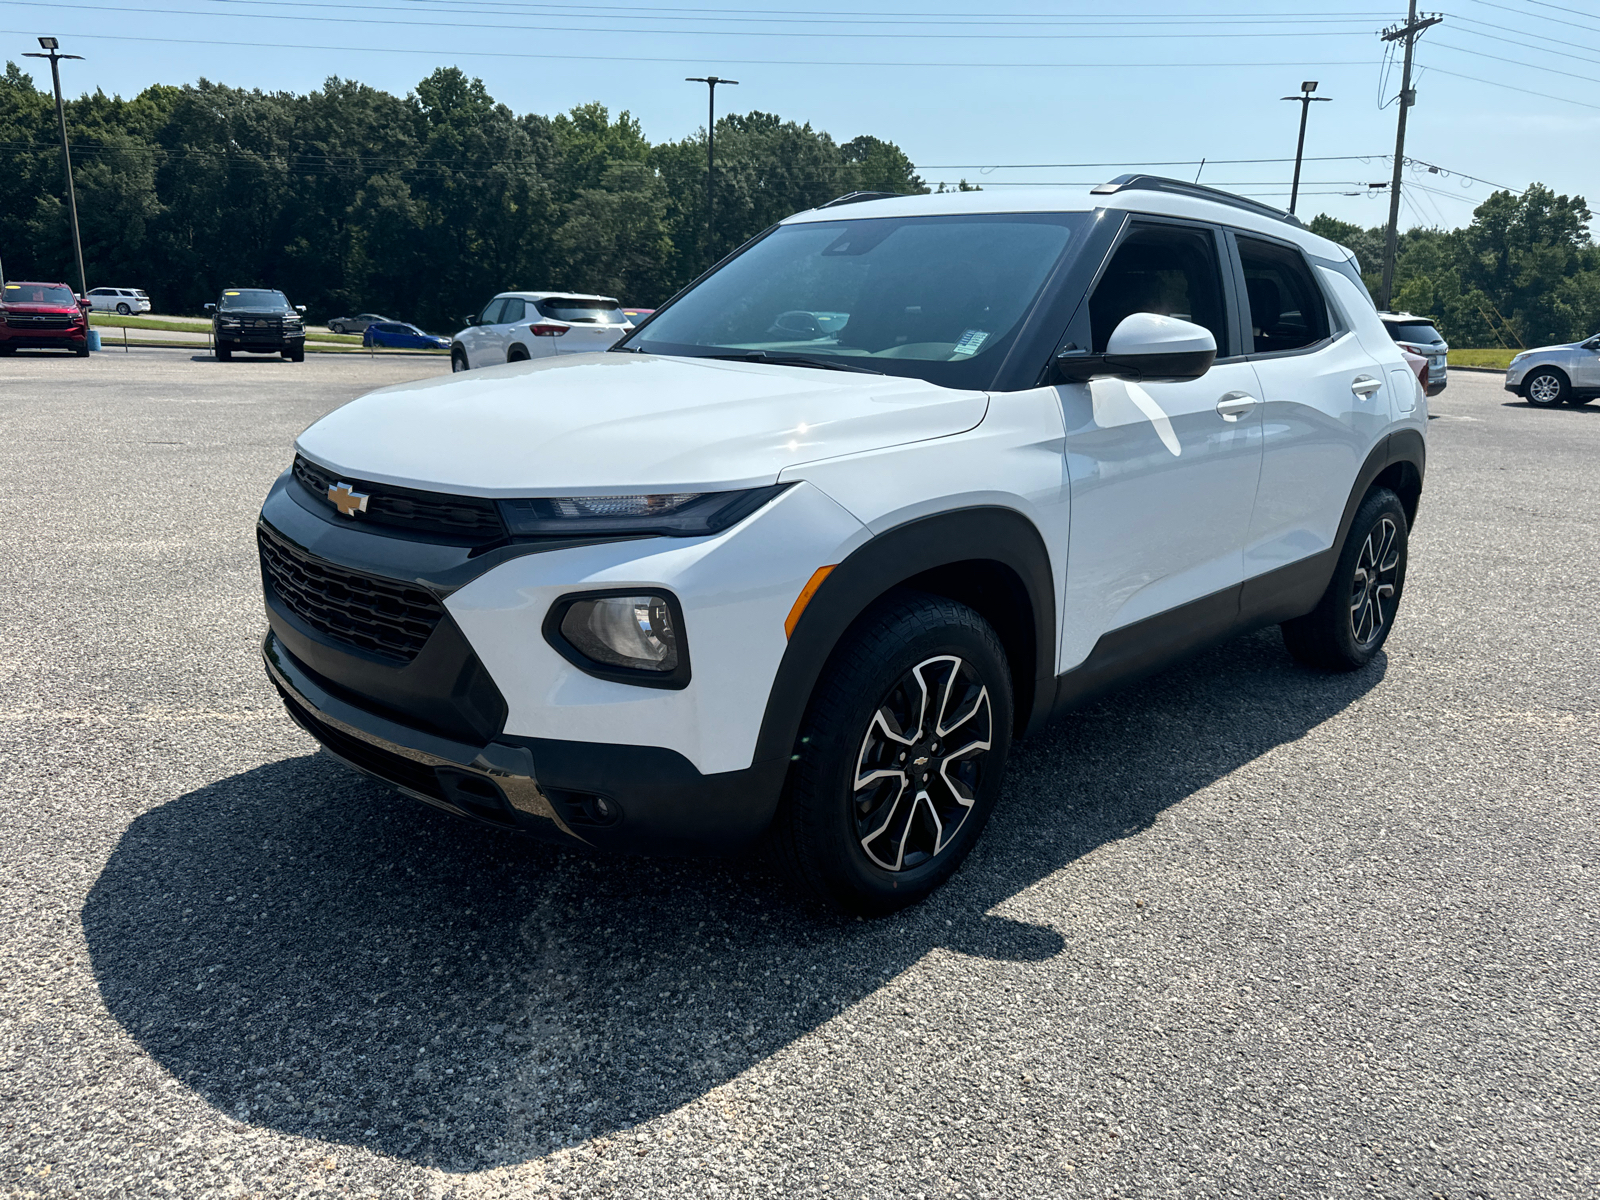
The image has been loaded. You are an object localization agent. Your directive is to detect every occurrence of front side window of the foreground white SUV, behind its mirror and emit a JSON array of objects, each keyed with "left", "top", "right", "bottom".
[{"left": 1090, "top": 226, "right": 1229, "bottom": 355}]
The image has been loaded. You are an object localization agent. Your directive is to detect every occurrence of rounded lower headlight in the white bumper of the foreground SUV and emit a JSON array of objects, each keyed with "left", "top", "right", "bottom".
[{"left": 544, "top": 590, "right": 690, "bottom": 688}]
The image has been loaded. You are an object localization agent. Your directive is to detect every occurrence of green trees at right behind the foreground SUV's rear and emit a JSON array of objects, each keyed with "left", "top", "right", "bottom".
[{"left": 1310, "top": 184, "right": 1600, "bottom": 349}]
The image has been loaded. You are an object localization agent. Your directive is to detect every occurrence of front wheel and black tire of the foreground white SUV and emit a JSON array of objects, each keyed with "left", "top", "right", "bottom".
[{"left": 773, "top": 592, "right": 1013, "bottom": 917}]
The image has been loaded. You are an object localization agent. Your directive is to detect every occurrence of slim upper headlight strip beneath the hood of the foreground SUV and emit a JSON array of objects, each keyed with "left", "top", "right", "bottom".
[{"left": 499, "top": 483, "right": 787, "bottom": 538}]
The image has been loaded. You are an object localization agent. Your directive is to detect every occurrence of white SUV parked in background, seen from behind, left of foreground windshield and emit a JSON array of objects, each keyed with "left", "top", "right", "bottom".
[{"left": 450, "top": 291, "right": 634, "bottom": 371}]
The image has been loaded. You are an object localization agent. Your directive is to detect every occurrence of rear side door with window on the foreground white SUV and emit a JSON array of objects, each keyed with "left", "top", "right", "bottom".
[{"left": 1229, "top": 232, "right": 1395, "bottom": 588}]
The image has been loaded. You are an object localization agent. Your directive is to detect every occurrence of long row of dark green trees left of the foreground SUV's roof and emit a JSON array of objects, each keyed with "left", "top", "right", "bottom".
[{"left": 0, "top": 62, "right": 928, "bottom": 330}]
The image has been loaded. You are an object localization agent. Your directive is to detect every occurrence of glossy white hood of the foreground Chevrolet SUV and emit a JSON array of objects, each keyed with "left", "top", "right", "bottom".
[{"left": 296, "top": 354, "right": 989, "bottom": 496}]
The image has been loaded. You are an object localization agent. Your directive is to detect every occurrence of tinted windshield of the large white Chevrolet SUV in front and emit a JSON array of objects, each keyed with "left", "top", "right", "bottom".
[{"left": 624, "top": 213, "right": 1088, "bottom": 387}]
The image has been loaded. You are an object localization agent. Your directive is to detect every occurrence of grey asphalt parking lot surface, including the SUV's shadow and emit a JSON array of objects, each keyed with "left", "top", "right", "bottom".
[{"left": 0, "top": 350, "right": 1600, "bottom": 1200}]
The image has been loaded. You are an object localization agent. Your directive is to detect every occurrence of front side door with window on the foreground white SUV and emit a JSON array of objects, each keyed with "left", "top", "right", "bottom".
[{"left": 1056, "top": 221, "right": 1261, "bottom": 670}]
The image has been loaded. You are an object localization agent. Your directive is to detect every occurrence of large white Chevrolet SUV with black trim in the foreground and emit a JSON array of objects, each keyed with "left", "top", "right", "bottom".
[{"left": 258, "top": 176, "right": 1427, "bottom": 914}]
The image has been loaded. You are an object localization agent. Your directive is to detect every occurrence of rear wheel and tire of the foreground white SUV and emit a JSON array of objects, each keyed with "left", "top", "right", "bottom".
[{"left": 1282, "top": 488, "right": 1410, "bottom": 670}]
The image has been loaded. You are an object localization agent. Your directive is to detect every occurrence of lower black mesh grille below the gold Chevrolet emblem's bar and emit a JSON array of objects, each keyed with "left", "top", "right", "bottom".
[{"left": 256, "top": 526, "right": 445, "bottom": 662}]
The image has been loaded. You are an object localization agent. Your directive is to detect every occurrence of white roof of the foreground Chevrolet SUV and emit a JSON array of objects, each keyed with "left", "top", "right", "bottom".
[{"left": 782, "top": 181, "right": 1350, "bottom": 262}]
